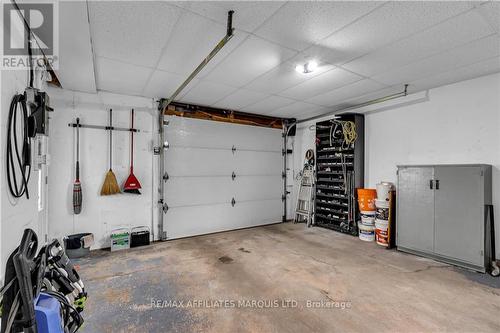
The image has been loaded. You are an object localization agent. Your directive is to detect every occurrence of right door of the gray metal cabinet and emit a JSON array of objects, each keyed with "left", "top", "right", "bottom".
[{"left": 434, "top": 166, "right": 484, "bottom": 266}]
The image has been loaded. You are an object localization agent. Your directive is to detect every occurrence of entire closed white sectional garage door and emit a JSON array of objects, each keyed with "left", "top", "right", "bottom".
[{"left": 164, "top": 117, "right": 283, "bottom": 239}]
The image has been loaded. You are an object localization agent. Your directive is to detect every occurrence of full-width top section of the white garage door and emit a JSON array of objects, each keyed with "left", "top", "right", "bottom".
[{"left": 165, "top": 117, "right": 282, "bottom": 151}]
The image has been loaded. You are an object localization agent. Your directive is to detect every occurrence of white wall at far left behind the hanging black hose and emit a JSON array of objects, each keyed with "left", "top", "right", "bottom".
[{"left": 0, "top": 70, "right": 45, "bottom": 281}]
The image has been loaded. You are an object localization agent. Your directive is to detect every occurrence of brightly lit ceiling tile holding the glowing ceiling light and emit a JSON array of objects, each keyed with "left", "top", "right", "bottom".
[{"left": 245, "top": 61, "right": 333, "bottom": 94}]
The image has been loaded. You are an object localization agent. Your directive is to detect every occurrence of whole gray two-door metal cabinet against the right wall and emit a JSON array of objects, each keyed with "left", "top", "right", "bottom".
[{"left": 396, "top": 164, "right": 491, "bottom": 272}]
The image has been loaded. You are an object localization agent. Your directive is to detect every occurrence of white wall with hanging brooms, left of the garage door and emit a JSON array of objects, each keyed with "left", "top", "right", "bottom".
[{"left": 49, "top": 89, "right": 156, "bottom": 248}]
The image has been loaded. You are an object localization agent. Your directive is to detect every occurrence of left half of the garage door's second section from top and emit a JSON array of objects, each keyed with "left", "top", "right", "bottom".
[{"left": 165, "top": 148, "right": 234, "bottom": 176}]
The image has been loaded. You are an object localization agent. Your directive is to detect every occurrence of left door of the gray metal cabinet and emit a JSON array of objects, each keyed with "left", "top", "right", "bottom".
[{"left": 396, "top": 167, "right": 434, "bottom": 253}]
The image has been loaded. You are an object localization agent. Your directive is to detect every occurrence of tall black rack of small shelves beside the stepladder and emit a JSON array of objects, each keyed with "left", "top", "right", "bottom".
[{"left": 314, "top": 113, "right": 365, "bottom": 235}]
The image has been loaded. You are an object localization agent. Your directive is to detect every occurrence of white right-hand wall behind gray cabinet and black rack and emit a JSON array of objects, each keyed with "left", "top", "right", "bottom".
[{"left": 294, "top": 74, "right": 500, "bottom": 258}]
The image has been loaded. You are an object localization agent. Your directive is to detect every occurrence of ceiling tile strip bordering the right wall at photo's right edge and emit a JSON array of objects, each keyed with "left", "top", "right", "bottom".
[{"left": 410, "top": 57, "right": 500, "bottom": 91}]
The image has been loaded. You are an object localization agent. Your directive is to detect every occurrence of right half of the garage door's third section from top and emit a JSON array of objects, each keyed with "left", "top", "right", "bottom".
[{"left": 232, "top": 176, "right": 283, "bottom": 201}]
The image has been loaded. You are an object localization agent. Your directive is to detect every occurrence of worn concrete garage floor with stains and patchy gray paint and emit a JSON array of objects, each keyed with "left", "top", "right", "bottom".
[{"left": 77, "top": 223, "right": 500, "bottom": 333}]
